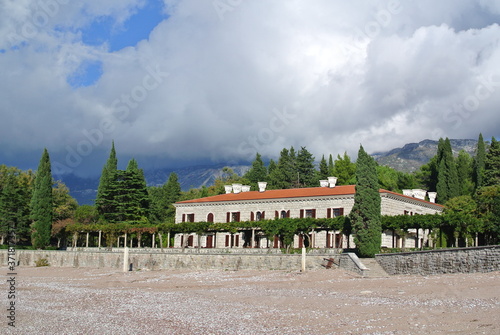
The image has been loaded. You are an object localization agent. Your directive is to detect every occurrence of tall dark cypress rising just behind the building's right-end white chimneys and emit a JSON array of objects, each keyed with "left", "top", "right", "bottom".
[{"left": 436, "top": 138, "right": 460, "bottom": 204}]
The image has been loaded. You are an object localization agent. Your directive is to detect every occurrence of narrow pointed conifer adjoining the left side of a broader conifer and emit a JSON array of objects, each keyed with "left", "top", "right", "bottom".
[{"left": 95, "top": 142, "right": 118, "bottom": 218}]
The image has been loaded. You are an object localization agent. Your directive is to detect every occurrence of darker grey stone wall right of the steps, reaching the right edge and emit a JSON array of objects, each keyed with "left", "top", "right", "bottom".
[{"left": 375, "top": 245, "right": 500, "bottom": 275}]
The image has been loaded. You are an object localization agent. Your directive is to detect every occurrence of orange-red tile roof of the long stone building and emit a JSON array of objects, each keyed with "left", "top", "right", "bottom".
[{"left": 177, "top": 185, "right": 442, "bottom": 207}]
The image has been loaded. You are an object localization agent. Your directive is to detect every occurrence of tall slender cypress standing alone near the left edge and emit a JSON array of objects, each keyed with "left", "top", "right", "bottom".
[{"left": 31, "top": 149, "right": 53, "bottom": 249}]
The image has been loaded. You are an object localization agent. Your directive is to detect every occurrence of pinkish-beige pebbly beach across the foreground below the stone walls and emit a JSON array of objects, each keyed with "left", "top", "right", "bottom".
[{"left": 0, "top": 267, "right": 500, "bottom": 334}]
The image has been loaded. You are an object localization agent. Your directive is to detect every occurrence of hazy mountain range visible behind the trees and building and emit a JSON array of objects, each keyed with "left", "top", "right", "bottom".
[{"left": 62, "top": 139, "right": 477, "bottom": 205}]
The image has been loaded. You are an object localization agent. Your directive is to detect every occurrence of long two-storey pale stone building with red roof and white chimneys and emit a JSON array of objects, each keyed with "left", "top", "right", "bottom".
[{"left": 174, "top": 181, "right": 443, "bottom": 248}]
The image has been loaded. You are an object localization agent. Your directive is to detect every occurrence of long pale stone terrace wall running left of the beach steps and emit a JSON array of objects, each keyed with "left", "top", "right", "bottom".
[{"left": 0, "top": 249, "right": 336, "bottom": 270}]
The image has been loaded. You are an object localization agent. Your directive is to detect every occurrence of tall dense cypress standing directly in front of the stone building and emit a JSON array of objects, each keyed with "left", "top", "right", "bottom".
[{"left": 350, "top": 146, "right": 382, "bottom": 257}]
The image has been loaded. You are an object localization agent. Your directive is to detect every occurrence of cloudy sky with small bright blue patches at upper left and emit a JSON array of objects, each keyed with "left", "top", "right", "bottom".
[{"left": 0, "top": 0, "right": 500, "bottom": 175}]
